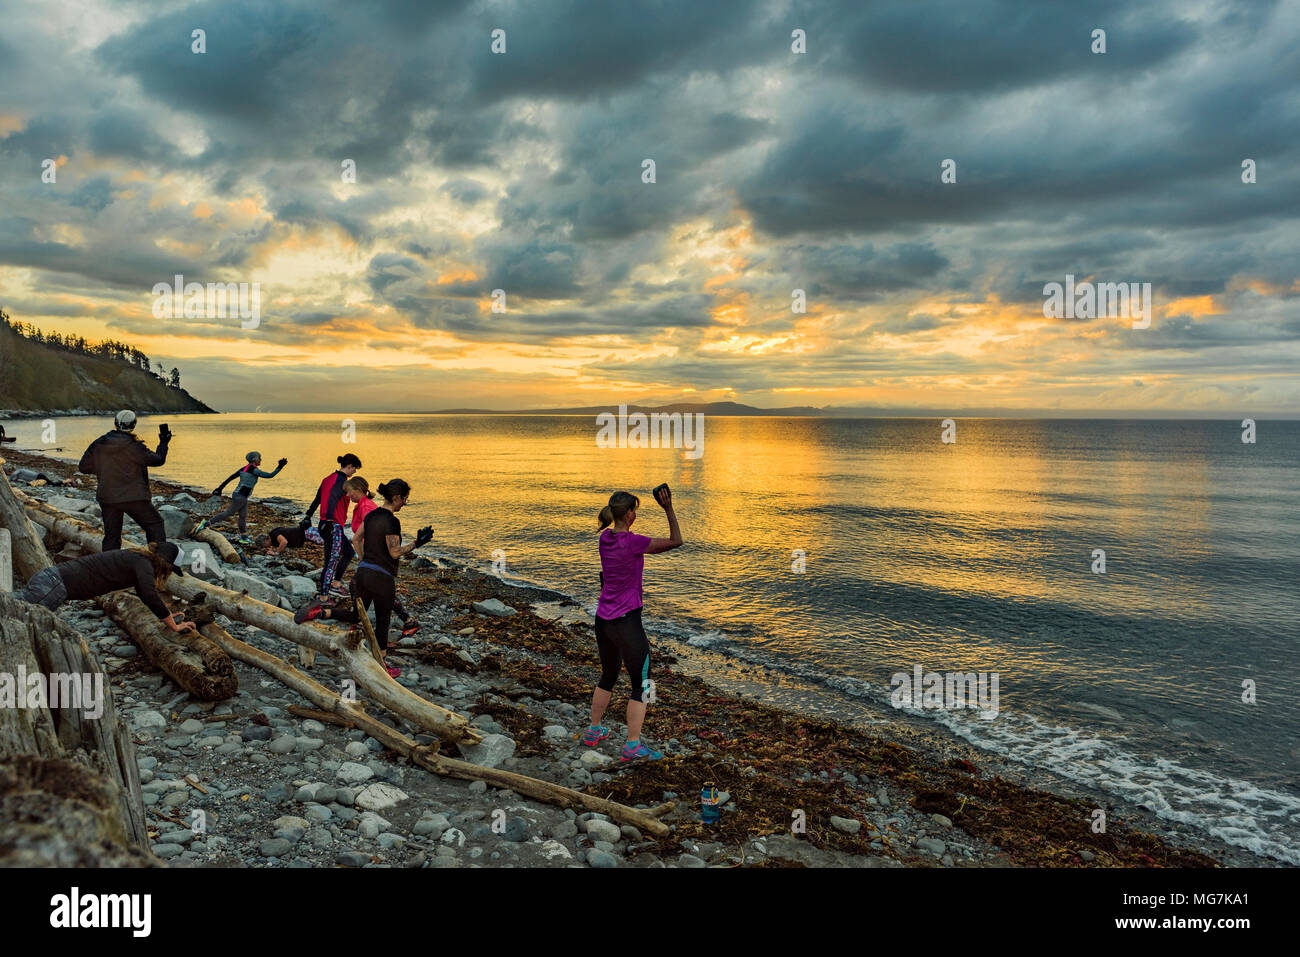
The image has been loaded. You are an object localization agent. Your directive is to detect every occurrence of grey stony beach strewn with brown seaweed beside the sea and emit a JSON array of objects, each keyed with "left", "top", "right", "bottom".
[{"left": 4, "top": 451, "right": 1258, "bottom": 867}]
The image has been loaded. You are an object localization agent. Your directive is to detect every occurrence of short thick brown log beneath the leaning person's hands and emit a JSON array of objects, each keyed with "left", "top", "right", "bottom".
[{"left": 95, "top": 592, "right": 239, "bottom": 701}]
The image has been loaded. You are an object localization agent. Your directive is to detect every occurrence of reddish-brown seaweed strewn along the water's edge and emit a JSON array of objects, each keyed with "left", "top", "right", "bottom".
[{"left": 419, "top": 587, "right": 1218, "bottom": 867}]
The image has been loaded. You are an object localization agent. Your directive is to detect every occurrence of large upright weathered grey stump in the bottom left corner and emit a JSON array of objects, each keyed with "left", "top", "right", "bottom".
[{"left": 0, "top": 594, "right": 159, "bottom": 867}]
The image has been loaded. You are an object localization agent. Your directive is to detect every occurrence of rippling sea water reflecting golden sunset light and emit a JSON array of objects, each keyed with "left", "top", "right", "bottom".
[{"left": 8, "top": 413, "right": 1300, "bottom": 863}]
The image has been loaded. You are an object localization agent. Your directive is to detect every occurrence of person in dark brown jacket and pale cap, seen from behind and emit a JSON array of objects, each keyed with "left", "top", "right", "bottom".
[{"left": 77, "top": 408, "right": 172, "bottom": 551}]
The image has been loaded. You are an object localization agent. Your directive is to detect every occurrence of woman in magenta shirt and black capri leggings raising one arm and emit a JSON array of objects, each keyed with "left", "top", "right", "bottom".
[{"left": 582, "top": 486, "right": 681, "bottom": 761}]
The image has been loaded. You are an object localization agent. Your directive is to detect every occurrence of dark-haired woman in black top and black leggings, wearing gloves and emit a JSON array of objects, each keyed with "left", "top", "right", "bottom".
[{"left": 294, "top": 479, "right": 433, "bottom": 677}]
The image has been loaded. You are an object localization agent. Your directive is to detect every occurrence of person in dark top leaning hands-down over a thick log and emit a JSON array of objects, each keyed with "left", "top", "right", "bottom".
[{"left": 18, "top": 542, "right": 195, "bottom": 632}]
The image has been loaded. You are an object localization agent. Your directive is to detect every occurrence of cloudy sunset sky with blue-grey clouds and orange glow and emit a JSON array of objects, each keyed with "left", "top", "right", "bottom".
[{"left": 0, "top": 0, "right": 1300, "bottom": 415}]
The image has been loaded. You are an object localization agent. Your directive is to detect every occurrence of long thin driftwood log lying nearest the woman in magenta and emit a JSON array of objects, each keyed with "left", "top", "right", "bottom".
[{"left": 202, "top": 624, "right": 673, "bottom": 837}]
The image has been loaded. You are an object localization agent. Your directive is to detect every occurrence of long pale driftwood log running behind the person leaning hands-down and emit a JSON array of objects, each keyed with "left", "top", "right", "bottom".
[{"left": 23, "top": 497, "right": 482, "bottom": 744}]
